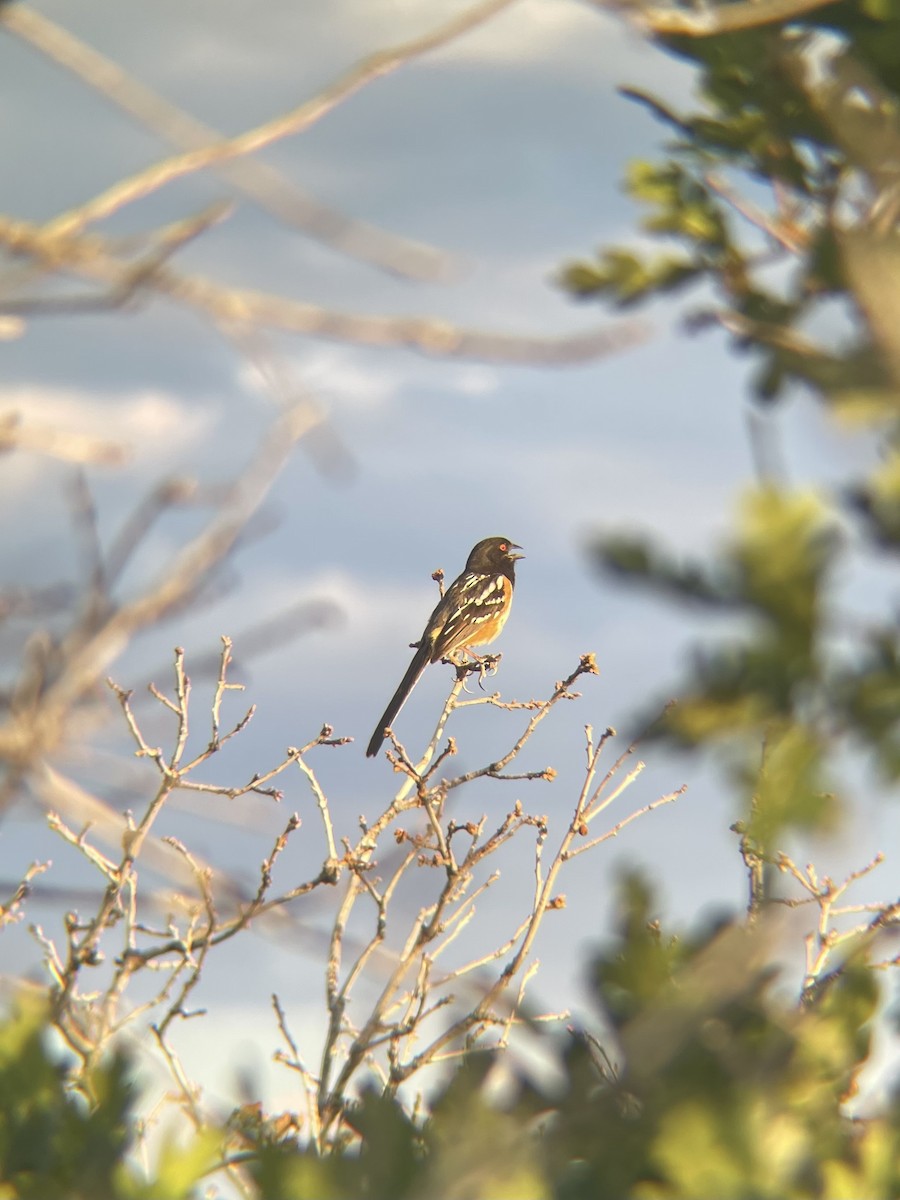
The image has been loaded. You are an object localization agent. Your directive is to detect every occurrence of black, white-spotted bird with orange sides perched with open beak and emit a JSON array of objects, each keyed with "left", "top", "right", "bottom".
[{"left": 366, "top": 538, "right": 524, "bottom": 758}]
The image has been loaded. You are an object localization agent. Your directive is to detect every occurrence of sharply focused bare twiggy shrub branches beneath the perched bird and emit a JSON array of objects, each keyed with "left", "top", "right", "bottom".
[{"left": 4, "top": 637, "right": 686, "bottom": 1165}]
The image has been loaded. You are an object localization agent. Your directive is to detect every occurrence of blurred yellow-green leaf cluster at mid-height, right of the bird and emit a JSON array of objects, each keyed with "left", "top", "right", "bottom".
[{"left": 594, "top": 487, "right": 849, "bottom": 848}]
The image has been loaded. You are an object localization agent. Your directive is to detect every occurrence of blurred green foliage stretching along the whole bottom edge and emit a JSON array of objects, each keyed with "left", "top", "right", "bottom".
[{"left": 7, "top": 877, "right": 900, "bottom": 1200}]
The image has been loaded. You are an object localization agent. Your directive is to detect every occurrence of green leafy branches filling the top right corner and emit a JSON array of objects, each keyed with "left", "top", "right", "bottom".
[{"left": 560, "top": 2, "right": 900, "bottom": 412}]
